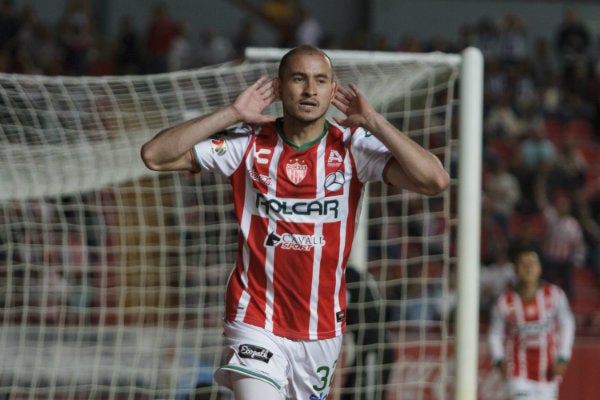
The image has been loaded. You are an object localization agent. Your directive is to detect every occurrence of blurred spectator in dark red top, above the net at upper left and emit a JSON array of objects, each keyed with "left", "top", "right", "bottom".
[{"left": 146, "top": 2, "right": 178, "bottom": 74}]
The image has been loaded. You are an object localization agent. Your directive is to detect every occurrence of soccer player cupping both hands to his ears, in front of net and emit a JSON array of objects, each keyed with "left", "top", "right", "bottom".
[{"left": 141, "top": 46, "right": 449, "bottom": 400}]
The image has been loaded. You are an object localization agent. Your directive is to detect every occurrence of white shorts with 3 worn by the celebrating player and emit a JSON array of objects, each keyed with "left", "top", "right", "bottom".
[{"left": 215, "top": 321, "right": 342, "bottom": 399}]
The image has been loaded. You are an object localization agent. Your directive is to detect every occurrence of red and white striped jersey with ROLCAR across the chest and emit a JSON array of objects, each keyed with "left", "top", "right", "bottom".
[{"left": 193, "top": 119, "right": 391, "bottom": 340}]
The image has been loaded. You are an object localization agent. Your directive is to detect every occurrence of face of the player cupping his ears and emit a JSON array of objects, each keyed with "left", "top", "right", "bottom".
[{"left": 279, "top": 54, "right": 336, "bottom": 123}]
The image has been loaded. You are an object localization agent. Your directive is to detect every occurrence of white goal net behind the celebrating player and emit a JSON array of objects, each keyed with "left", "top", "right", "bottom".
[{"left": 0, "top": 47, "right": 478, "bottom": 400}]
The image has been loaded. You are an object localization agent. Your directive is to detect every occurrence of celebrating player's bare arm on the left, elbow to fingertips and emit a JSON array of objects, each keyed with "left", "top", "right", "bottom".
[{"left": 141, "top": 77, "right": 276, "bottom": 171}]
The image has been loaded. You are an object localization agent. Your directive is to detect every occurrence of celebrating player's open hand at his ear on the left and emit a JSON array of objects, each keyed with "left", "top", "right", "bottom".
[{"left": 232, "top": 76, "right": 277, "bottom": 124}]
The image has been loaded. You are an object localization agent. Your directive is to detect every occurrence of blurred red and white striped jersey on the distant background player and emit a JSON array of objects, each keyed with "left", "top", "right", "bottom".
[{"left": 488, "top": 283, "right": 575, "bottom": 382}]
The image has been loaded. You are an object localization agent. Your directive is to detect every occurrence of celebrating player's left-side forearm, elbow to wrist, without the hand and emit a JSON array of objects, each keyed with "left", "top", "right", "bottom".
[{"left": 141, "top": 106, "right": 241, "bottom": 171}]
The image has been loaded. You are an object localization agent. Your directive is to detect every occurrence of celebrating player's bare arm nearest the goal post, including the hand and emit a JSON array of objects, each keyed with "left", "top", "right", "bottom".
[{"left": 332, "top": 83, "right": 450, "bottom": 195}]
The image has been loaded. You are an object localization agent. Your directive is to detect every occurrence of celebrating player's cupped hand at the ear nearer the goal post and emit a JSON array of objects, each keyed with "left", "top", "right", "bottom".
[{"left": 332, "top": 83, "right": 375, "bottom": 127}]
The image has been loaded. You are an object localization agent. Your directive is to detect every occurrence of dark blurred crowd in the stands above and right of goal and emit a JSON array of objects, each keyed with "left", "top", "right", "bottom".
[{"left": 0, "top": 0, "right": 600, "bottom": 330}]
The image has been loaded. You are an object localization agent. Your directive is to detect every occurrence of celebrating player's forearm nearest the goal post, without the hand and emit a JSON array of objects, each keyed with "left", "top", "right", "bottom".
[{"left": 363, "top": 112, "right": 450, "bottom": 195}]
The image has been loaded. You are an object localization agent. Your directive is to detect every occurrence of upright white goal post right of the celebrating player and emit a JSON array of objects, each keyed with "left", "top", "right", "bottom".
[{"left": 454, "top": 47, "right": 484, "bottom": 400}]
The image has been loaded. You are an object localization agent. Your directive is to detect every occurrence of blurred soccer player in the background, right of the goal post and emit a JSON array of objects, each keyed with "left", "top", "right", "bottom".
[{"left": 488, "top": 243, "right": 575, "bottom": 400}]
